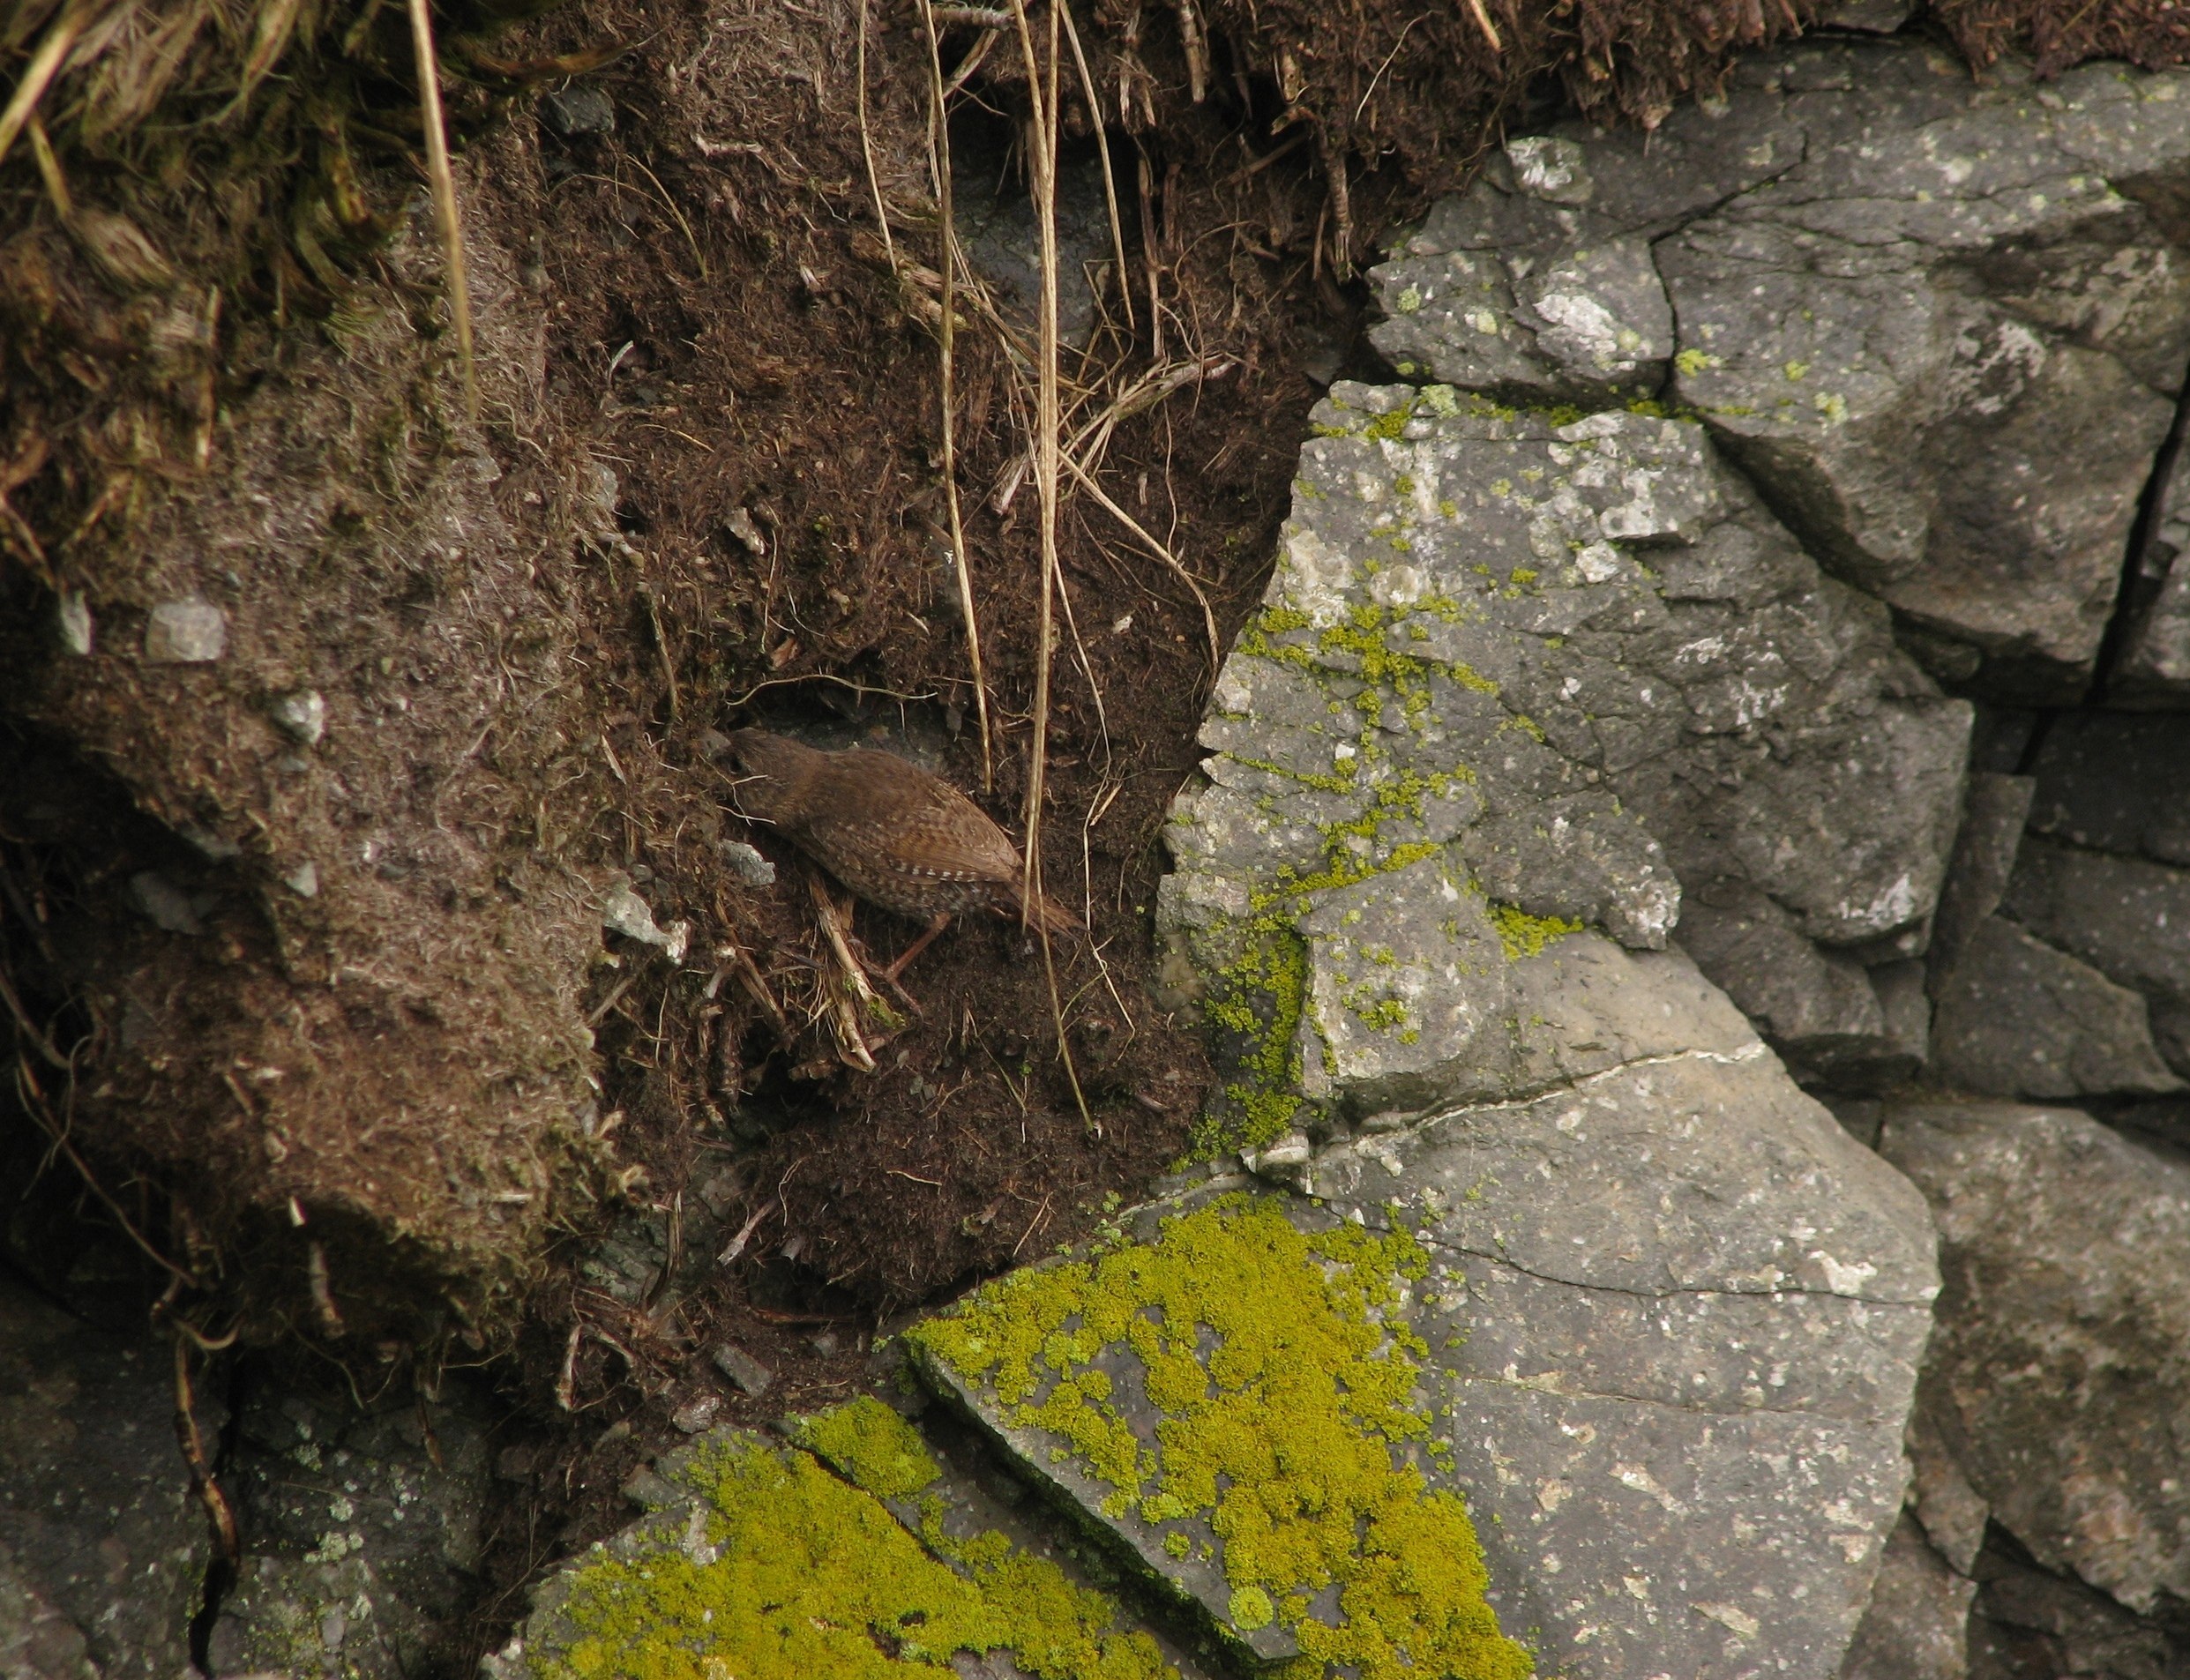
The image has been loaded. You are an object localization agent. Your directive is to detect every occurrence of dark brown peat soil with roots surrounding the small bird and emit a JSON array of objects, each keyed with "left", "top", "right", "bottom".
[{"left": 418, "top": 0, "right": 1360, "bottom": 1662}]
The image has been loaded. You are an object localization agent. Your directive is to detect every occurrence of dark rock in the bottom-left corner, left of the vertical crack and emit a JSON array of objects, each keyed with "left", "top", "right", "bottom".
[{"left": 0, "top": 1277, "right": 223, "bottom": 1680}]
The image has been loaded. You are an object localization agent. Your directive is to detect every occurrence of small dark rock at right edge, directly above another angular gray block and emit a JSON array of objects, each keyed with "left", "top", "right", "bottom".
[{"left": 2001, "top": 839, "right": 2190, "bottom": 1042}]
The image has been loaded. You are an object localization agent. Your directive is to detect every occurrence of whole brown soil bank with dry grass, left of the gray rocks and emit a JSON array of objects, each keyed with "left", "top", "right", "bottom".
[{"left": 0, "top": 0, "right": 2190, "bottom": 1348}]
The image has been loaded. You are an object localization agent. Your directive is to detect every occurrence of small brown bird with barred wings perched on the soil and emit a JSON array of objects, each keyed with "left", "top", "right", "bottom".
[{"left": 729, "top": 729, "right": 1080, "bottom": 979}]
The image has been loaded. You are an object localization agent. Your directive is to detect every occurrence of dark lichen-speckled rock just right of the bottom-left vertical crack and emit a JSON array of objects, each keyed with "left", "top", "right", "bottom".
[{"left": 210, "top": 1378, "right": 493, "bottom": 1680}]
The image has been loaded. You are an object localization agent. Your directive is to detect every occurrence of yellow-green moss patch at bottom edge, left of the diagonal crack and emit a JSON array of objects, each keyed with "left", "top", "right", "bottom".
[{"left": 532, "top": 1437, "right": 1176, "bottom": 1680}]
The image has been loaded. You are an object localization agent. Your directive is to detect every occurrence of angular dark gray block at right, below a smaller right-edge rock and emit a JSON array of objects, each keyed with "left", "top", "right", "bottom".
[{"left": 1932, "top": 915, "right": 2181, "bottom": 1100}]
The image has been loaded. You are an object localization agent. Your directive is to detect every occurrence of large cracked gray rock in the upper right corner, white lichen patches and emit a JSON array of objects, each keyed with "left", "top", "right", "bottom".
[{"left": 1371, "top": 41, "right": 2190, "bottom": 698}]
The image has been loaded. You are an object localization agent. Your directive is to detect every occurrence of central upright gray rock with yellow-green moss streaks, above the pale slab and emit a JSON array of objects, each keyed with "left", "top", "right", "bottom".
[{"left": 1161, "top": 384, "right": 1969, "bottom": 1141}]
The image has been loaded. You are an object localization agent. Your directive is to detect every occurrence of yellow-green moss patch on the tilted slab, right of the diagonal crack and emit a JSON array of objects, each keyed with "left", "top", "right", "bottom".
[{"left": 908, "top": 1198, "right": 1531, "bottom": 1680}]
